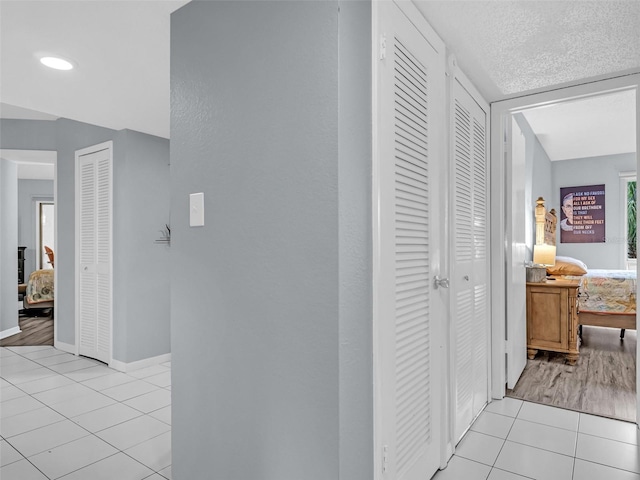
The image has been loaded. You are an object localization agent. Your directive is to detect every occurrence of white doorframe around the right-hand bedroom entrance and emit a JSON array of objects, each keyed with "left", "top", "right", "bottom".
[{"left": 491, "top": 73, "right": 640, "bottom": 412}]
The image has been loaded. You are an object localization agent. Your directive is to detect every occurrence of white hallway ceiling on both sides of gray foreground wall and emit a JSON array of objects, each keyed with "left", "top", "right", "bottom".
[{"left": 0, "top": 0, "right": 640, "bottom": 158}]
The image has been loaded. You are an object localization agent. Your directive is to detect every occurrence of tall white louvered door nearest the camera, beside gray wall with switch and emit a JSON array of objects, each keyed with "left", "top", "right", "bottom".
[{"left": 376, "top": 2, "right": 445, "bottom": 480}]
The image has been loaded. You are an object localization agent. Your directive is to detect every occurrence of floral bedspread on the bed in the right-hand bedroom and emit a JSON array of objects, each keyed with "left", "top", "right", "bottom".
[{"left": 578, "top": 269, "right": 636, "bottom": 313}]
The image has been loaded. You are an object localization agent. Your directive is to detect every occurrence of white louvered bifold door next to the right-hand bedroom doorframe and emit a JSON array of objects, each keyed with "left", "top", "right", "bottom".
[{"left": 451, "top": 78, "right": 490, "bottom": 443}]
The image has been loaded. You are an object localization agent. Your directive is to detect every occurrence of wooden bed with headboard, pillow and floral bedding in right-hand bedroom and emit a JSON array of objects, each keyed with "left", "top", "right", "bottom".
[{"left": 536, "top": 198, "right": 637, "bottom": 338}]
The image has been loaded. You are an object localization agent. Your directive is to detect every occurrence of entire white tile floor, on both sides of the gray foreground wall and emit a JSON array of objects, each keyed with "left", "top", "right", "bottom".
[{"left": 0, "top": 346, "right": 640, "bottom": 480}]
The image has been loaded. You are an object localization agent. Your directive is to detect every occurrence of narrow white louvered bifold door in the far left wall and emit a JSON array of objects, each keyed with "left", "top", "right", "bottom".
[{"left": 76, "top": 144, "right": 112, "bottom": 363}]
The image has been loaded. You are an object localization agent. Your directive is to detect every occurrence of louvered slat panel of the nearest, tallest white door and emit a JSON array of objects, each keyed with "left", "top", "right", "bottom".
[{"left": 394, "top": 35, "right": 432, "bottom": 478}]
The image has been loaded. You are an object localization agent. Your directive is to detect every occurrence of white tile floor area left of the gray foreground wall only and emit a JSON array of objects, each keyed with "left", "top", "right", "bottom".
[{"left": 0, "top": 346, "right": 171, "bottom": 480}]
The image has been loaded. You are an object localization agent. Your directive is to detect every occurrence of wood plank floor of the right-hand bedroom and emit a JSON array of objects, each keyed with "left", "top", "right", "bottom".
[{"left": 507, "top": 327, "right": 637, "bottom": 422}]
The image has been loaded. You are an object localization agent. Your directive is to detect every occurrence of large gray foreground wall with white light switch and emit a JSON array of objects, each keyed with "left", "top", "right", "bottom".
[{"left": 171, "top": 1, "right": 373, "bottom": 480}]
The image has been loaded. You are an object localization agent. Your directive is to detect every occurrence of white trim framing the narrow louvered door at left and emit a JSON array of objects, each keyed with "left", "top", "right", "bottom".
[{"left": 74, "top": 140, "right": 114, "bottom": 365}]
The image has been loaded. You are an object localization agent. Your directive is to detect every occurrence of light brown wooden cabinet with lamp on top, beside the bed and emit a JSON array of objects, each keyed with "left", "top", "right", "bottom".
[{"left": 527, "top": 279, "right": 582, "bottom": 365}]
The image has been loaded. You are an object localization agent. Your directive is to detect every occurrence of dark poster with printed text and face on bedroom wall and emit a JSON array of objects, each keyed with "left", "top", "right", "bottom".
[{"left": 560, "top": 185, "right": 606, "bottom": 243}]
